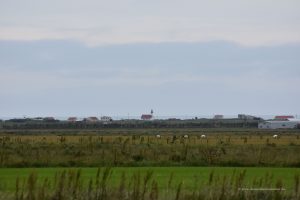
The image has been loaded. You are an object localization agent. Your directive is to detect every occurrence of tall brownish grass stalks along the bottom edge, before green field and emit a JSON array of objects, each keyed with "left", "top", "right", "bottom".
[{"left": 7, "top": 168, "right": 300, "bottom": 200}]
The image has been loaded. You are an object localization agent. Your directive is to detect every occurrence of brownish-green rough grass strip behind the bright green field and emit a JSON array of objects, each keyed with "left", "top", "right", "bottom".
[{"left": 0, "top": 132, "right": 300, "bottom": 167}]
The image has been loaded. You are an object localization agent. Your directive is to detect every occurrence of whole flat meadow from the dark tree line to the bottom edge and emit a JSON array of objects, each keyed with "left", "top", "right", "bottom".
[{"left": 0, "top": 129, "right": 300, "bottom": 200}]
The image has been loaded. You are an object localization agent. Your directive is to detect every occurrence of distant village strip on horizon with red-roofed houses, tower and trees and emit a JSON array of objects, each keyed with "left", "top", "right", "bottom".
[{"left": 0, "top": 109, "right": 300, "bottom": 129}]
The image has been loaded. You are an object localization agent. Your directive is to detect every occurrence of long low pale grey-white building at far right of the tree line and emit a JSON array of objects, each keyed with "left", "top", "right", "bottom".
[{"left": 258, "top": 121, "right": 299, "bottom": 129}]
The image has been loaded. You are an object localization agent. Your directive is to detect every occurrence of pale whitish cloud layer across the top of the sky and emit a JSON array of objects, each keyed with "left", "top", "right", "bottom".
[{"left": 0, "top": 0, "right": 300, "bottom": 46}]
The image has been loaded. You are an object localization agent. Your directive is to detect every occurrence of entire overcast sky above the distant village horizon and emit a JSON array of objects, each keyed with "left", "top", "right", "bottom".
[{"left": 0, "top": 0, "right": 300, "bottom": 117}]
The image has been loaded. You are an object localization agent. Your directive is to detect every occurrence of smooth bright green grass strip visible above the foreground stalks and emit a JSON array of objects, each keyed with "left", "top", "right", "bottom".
[{"left": 0, "top": 167, "right": 300, "bottom": 191}]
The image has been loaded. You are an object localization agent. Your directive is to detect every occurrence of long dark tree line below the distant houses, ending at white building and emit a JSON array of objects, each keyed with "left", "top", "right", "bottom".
[{"left": 0, "top": 120, "right": 259, "bottom": 129}]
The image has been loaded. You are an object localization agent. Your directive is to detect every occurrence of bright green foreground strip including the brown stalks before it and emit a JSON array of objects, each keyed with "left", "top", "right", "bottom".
[{"left": 0, "top": 167, "right": 300, "bottom": 200}]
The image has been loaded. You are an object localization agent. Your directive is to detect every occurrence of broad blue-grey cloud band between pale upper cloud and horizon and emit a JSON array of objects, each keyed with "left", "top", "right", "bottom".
[{"left": 0, "top": 40, "right": 300, "bottom": 116}]
